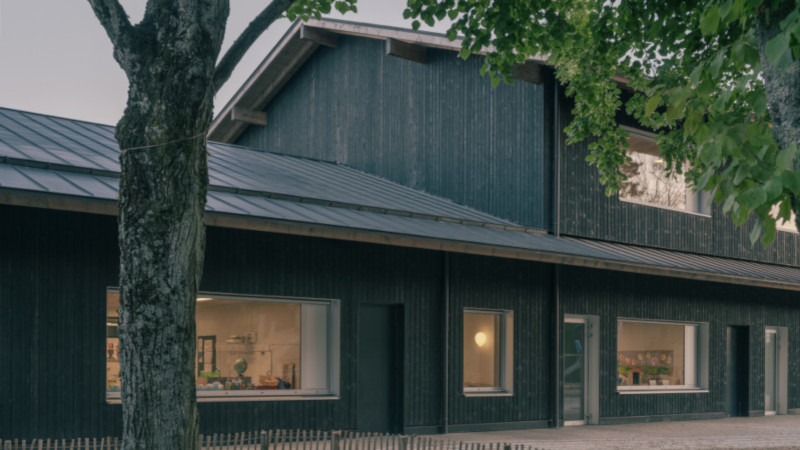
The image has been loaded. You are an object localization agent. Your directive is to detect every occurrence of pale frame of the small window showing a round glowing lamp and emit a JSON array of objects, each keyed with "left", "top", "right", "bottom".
[{"left": 461, "top": 308, "right": 514, "bottom": 397}]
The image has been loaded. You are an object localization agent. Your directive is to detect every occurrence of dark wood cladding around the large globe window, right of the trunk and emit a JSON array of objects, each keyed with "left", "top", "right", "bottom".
[{"left": 200, "top": 228, "right": 443, "bottom": 433}]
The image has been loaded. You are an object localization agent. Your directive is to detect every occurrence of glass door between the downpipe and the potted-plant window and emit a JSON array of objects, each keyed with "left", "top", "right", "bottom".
[{"left": 563, "top": 317, "right": 587, "bottom": 425}]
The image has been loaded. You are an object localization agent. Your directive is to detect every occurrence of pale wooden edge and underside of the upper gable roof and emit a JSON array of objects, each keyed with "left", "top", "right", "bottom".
[{"left": 208, "top": 19, "right": 542, "bottom": 142}]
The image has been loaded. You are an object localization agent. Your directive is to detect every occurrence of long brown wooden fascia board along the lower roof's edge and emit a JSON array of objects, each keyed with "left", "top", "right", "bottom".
[{"left": 0, "top": 191, "right": 800, "bottom": 291}]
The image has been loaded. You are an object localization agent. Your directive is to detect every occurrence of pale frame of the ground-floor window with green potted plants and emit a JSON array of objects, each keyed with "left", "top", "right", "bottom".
[{"left": 614, "top": 317, "right": 708, "bottom": 394}]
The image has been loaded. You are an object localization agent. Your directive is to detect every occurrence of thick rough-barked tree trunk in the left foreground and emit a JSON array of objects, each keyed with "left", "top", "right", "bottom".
[{"left": 98, "top": 0, "right": 228, "bottom": 449}]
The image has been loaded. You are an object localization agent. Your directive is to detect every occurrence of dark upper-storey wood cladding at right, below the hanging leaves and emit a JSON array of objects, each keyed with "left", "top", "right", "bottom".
[{"left": 560, "top": 93, "right": 800, "bottom": 267}]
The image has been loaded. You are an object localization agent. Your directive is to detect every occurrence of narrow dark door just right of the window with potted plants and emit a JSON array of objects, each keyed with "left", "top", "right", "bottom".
[{"left": 725, "top": 326, "right": 750, "bottom": 416}]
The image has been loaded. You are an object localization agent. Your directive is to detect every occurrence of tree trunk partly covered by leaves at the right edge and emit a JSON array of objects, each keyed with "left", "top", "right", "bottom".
[{"left": 756, "top": 0, "right": 800, "bottom": 230}]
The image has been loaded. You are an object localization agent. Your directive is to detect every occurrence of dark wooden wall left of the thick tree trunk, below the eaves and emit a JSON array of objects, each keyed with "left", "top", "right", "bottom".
[{"left": 0, "top": 206, "right": 119, "bottom": 438}]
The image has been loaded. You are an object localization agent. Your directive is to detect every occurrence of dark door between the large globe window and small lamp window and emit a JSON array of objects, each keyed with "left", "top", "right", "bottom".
[{"left": 357, "top": 304, "right": 403, "bottom": 433}]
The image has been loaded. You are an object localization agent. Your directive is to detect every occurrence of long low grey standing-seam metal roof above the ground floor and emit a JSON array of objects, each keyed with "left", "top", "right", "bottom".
[{"left": 0, "top": 108, "right": 800, "bottom": 290}]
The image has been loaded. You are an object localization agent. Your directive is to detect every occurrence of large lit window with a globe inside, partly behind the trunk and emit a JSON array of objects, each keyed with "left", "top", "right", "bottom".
[{"left": 106, "top": 292, "right": 339, "bottom": 400}]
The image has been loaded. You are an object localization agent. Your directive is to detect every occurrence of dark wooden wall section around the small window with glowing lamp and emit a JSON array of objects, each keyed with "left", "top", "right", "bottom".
[{"left": 449, "top": 255, "right": 553, "bottom": 425}]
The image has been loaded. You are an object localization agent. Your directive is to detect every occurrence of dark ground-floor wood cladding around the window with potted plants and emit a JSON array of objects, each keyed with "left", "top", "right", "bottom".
[{"left": 561, "top": 267, "right": 800, "bottom": 418}]
